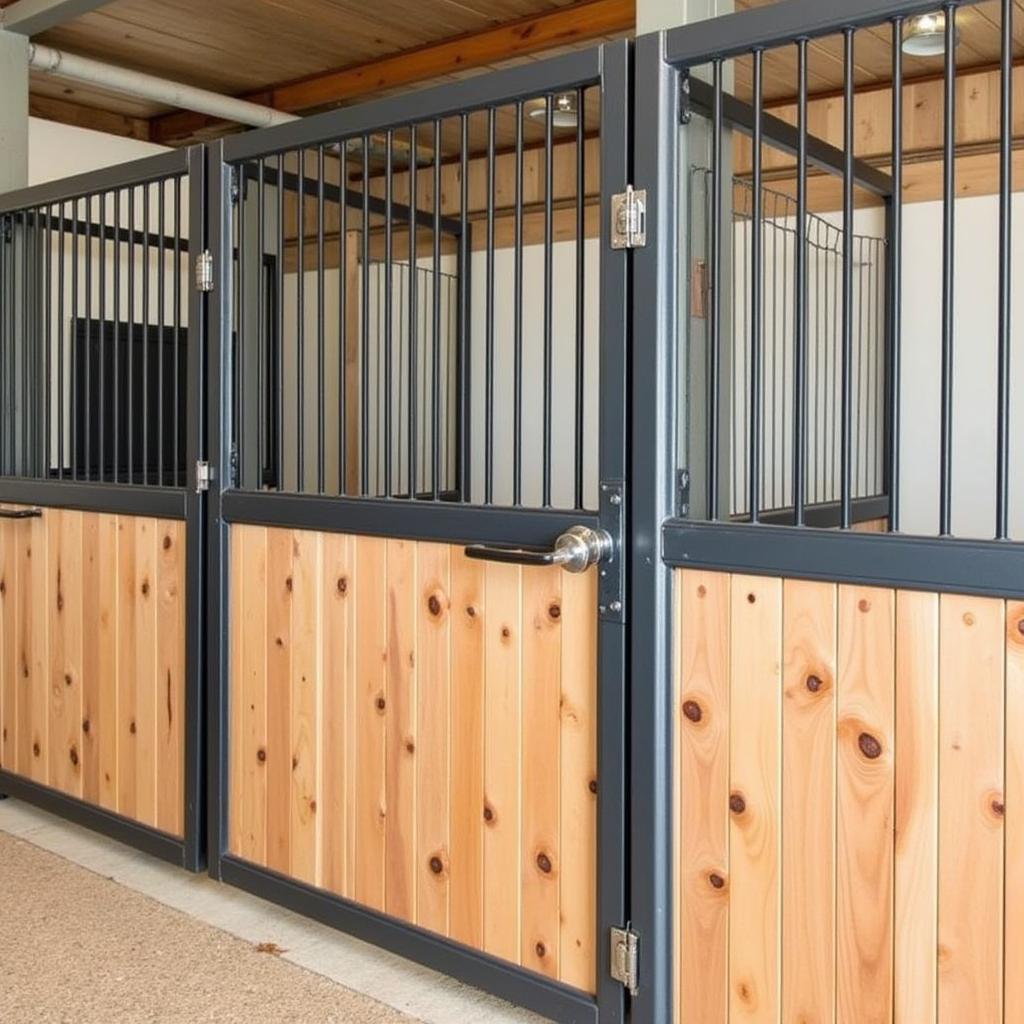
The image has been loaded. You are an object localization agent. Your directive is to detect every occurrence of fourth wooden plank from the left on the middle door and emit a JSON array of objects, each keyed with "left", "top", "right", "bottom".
[{"left": 319, "top": 534, "right": 355, "bottom": 896}]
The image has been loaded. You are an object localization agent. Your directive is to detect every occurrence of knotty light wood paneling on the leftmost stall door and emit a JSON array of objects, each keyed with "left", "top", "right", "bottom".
[{"left": 0, "top": 506, "right": 185, "bottom": 837}]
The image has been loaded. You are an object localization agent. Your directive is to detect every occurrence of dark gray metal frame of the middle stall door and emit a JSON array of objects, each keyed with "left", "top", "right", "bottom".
[{"left": 207, "top": 42, "right": 631, "bottom": 1022}]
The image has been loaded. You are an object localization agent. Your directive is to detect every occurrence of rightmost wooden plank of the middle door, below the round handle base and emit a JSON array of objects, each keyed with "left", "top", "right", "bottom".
[{"left": 558, "top": 568, "right": 598, "bottom": 992}]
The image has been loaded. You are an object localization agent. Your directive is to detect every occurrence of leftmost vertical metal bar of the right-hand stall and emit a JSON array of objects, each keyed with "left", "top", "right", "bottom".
[{"left": 708, "top": 60, "right": 725, "bottom": 521}]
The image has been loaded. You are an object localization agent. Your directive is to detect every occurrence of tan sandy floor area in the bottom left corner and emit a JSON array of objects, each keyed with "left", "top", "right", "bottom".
[{"left": 0, "top": 834, "right": 414, "bottom": 1024}]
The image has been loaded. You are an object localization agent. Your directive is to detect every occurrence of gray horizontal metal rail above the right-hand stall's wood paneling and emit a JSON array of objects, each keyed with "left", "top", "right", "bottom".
[{"left": 663, "top": 519, "right": 1024, "bottom": 598}]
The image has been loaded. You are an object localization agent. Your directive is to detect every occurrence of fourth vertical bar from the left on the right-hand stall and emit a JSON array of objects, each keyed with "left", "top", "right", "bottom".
[{"left": 840, "top": 29, "right": 854, "bottom": 529}]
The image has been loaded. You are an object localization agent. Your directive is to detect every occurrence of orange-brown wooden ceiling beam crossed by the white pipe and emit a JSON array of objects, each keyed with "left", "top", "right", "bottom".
[{"left": 152, "top": 0, "right": 636, "bottom": 145}]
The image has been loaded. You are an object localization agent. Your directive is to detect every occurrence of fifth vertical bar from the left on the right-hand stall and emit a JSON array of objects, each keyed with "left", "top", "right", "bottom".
[{"left": 886, "top": 16, "right": 905, "bottom": 532}]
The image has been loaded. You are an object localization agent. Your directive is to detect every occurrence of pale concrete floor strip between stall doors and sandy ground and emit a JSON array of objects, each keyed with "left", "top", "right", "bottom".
[{"left": 0, "top": 800, "right": 543, "bottom": 1024}]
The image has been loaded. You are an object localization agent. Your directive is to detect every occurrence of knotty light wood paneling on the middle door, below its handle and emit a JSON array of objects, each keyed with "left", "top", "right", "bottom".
[{"left": 229, "top": 525, "right": 599, "bottom": 991}]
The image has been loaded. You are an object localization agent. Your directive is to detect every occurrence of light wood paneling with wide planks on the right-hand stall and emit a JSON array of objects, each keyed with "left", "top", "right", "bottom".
[{"left": 676, "top": 570, "right": 1024, "bottom": 1024}]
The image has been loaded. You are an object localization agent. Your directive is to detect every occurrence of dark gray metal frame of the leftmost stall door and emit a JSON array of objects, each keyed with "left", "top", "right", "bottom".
[{"left": 0, "top": 146, "right": 207, "bottom": 871}]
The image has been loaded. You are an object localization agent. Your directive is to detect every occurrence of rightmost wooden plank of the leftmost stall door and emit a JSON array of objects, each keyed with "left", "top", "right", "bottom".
[{"left": 155, "top": 519, "right": 185, "bottom": 836}]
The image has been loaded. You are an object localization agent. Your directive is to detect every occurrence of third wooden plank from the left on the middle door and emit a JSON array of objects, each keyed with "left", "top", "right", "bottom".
[{"left": 290, "top": 529, "right": 323, "bottom": 886}]
